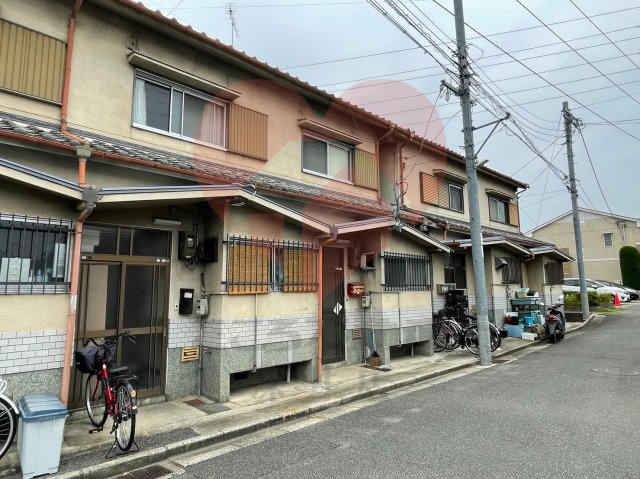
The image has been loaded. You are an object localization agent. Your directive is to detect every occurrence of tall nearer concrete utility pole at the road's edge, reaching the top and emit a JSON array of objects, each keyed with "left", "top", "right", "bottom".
[{"left": 453, "top": 0, "right": 491, "bottom": 366}]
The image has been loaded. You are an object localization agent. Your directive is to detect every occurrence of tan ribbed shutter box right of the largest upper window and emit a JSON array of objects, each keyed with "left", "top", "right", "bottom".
[{"left": 229, "top": 103, "right": 268, "bottom": 160}]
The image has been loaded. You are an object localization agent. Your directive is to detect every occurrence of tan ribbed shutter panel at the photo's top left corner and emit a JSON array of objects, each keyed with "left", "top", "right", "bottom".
[{"left": 0, "top": 19, "right": 66, "bottom": 103}]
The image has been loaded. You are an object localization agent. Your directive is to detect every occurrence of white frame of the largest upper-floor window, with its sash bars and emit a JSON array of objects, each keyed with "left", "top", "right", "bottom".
[{"left": 131, "top": 70, "right": 229, "bottom": 151}]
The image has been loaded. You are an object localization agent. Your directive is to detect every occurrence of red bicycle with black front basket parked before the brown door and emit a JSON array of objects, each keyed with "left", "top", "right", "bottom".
[{"left": 75, "top": 331, "right": 138, "bottom": 457}]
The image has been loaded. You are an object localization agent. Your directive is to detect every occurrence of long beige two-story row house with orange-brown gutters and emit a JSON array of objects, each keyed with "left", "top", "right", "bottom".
[{"left": 0, "top": 0, "right": 568, "bottom": 406}]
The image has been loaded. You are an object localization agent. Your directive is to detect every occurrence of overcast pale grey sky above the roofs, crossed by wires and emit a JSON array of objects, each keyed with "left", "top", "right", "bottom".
[{"left": 138, "top": 0, "right": 640, "bottom": 239}]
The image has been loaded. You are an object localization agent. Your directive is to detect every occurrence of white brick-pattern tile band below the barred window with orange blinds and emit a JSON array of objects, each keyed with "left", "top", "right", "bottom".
[{"left": 203, "top": 314, "right": 318, "bottom": 349}]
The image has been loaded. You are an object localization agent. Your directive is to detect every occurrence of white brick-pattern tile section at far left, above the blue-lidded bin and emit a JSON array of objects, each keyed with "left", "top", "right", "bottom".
[{"left": 0, "top": 329, "right": 67, "bottom": 376}]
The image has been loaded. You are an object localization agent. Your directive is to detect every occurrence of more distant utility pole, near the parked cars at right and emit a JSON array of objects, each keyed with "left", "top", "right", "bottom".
[{"left": 562, "top": 101, "right": 589, "bottom": 321}]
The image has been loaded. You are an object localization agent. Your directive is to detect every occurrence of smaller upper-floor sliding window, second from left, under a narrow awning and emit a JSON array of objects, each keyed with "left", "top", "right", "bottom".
[{"left": 302, "top": 132, "right": 353, "bottom": 182}]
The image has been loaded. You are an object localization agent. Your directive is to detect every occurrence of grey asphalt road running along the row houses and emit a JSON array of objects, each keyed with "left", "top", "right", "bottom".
[{"left": 156, "top": 302, "right": 640, "bottom": 479}]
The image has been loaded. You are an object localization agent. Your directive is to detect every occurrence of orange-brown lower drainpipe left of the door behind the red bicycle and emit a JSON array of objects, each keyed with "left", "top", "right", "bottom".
[{"left": 60, "top": 187, "right": 98, "bottom": 407}]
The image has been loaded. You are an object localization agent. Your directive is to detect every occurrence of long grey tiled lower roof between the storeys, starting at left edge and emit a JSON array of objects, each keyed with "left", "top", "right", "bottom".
[{"left": 0, "top": 112, "right": 392, "bottom": 214}]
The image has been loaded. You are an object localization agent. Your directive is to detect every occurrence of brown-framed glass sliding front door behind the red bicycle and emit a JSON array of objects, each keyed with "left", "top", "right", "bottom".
[{"left": 70, "top": 225, "right": 170, "bottom": 407}]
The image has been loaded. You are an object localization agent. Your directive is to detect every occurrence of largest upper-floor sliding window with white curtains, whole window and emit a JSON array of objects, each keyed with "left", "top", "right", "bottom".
[{"left": 133, "top": 72, "right": 226, "bottom": 148}]
